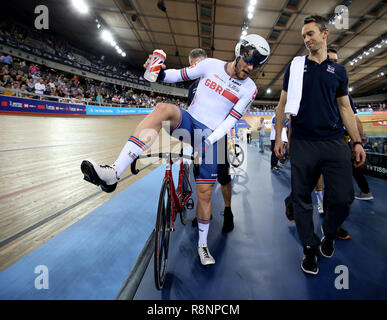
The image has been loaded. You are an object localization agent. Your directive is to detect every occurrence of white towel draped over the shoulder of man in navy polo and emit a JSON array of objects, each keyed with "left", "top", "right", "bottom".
[{"left": 285, "top": 56, "right": 306, "bottom": 116}]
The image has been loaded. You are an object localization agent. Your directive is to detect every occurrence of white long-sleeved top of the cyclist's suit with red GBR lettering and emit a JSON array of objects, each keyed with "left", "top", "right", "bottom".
[{"left": 160, "top": 58, "right": 257, "bottom": 144}]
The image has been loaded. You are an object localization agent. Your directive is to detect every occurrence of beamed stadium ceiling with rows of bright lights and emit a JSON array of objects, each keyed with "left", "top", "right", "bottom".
[{"left": 3, "top": 0, "right": 387, "bottom": 100}]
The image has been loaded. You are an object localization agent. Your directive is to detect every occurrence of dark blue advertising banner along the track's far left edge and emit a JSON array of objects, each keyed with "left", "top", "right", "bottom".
[{"left": 0, "top": 95, "right": 86, "bottom": 115}]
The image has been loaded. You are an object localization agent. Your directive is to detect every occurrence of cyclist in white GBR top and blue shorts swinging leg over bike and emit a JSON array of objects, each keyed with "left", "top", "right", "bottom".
[{"left": 81, "top": 34, "right": 270, "bottom": 265}]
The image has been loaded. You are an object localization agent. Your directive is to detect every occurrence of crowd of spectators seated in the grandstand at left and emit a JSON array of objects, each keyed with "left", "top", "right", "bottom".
[{"left": 0, "top": 53, "right": 185, "bottom": 107}]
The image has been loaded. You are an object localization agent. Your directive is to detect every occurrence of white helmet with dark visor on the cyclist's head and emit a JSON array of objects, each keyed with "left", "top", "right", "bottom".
[{"left": 235, "top": 34, "right": 270, "bottom": 69}]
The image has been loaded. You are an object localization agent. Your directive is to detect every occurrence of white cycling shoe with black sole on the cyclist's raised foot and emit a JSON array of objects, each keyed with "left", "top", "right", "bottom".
[{"left": 81, "top": 160, "right": 120, "bottom": 192}]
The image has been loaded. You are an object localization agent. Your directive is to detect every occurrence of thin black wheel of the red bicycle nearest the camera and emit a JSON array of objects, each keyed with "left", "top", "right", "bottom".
[{"left": 153, "top": 179, "right": 171, "bottom": 290}]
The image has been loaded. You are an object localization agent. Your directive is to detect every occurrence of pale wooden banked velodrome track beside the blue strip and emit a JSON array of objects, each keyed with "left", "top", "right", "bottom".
[{"left": 0, "top": 114, "right": 387, "bottom": 271}]
